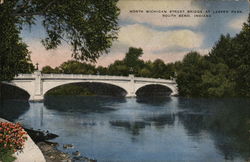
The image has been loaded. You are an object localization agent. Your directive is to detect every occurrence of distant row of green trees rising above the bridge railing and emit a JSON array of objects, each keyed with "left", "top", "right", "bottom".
[{"left": 42, "top": 47, "right": 175, "bottom": 79}]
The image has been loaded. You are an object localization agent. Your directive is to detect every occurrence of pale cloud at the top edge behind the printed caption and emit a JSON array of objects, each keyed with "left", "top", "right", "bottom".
[{"left": 118, "top": 0, "right": 205, "bottom": 27}]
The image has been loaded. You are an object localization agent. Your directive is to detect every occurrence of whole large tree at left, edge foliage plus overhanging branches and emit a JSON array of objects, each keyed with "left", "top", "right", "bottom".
[{"left": 0, "top": 0, "right": 119, "bottom": 83}]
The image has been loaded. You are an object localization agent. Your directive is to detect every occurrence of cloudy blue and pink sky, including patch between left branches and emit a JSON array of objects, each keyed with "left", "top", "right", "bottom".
[{"left": 22, "top": 0, "right": 250, "bottom": 69}]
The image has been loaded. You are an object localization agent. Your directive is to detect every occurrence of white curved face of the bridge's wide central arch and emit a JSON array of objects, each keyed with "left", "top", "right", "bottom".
[{"left": 43, "top": 80, "right": 128, "bottom": 96}]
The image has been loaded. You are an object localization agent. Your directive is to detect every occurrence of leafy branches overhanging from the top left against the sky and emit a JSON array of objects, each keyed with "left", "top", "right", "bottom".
[{"left": 1, "top": 0, "right": 119, "bottom": 61}]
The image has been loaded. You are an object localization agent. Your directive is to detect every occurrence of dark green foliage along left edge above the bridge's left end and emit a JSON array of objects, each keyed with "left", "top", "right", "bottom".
[{"left": 0, "top": 5, "right": 34, "bottom": 81}]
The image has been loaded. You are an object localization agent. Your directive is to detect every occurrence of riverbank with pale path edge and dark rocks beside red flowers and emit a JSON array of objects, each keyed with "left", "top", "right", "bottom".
[{"left": 0, "top": 118, "right": 96, "bottom": 162}]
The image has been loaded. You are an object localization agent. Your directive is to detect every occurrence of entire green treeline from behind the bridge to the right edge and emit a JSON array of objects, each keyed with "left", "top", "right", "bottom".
[{"left": 42, "top": 16, "right": 250, "bottom": 97}]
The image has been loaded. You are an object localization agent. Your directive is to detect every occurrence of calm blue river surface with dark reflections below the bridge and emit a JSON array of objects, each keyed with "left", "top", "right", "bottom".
[{"left": 0, "top": 97, "right": 250, "bottom": 162}]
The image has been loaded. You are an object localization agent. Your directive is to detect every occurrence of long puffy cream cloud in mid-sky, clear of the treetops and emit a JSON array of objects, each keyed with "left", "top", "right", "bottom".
[{"left": 118, "top": 24, "right": 203, "bottom": 52}]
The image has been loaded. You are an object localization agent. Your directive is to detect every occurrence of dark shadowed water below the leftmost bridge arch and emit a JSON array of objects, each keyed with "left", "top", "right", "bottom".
[{"left": 0, "top": 100, "right": 30, "bottom": 121}]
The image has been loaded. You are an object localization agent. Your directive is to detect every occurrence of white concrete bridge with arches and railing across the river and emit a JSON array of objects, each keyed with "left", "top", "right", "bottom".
[{"left": 4, "top": 71, "right": 178, "bottom": 101}]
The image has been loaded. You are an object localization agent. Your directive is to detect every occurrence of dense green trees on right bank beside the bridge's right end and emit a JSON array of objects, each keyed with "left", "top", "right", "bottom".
[{"left": 177, "top": 15, "right": 250, "bottom": 97}]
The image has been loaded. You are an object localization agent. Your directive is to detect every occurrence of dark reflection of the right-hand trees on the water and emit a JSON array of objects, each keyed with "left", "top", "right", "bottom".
[{"left": 178, "top": 99, "right": 250, "bottom": 160}]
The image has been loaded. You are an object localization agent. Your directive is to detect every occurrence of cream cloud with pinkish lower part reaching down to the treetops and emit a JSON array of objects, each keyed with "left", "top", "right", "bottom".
[{"left": 94, "top": 24, "right": 204, "bottom": 66}]
